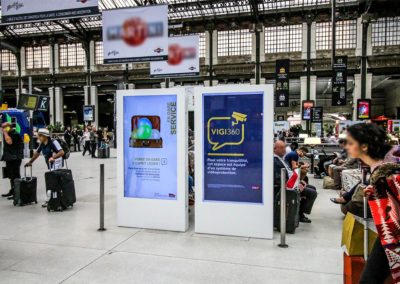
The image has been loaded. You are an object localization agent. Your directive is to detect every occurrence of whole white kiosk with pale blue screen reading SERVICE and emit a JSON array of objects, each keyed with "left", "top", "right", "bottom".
[{"left": 117, "top": 88, "right": 188, "bottom": 231}]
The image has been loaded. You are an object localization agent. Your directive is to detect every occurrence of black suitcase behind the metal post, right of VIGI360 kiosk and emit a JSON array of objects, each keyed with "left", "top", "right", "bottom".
[{"left": 274, "top": 190, "right": 300, "bottom": 234}]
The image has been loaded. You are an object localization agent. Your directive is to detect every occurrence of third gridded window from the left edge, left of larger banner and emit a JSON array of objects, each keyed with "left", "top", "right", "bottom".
[{"left": 59, "top": 43, "right": 86, "bottom": 67}]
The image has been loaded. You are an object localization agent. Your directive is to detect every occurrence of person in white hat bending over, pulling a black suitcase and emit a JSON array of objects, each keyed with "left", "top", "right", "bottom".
[{"left": 25, "top": 128, "right": 65, "bottom": 169}]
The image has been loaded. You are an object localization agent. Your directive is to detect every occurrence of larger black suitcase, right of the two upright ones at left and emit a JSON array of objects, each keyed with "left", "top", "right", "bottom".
[{"left": 45, "top": 166, "right": 76, "bottom": 211}]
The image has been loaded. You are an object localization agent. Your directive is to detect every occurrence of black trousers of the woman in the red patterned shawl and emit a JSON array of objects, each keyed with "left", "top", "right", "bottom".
[{"left": 360, "top": 238, "right": 390, "bottom": 284}]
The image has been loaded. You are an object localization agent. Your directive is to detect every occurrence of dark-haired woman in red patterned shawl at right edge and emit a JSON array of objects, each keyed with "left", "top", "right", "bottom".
[{"left": 346, "top": 123, "right": 400, "bottom": 284}]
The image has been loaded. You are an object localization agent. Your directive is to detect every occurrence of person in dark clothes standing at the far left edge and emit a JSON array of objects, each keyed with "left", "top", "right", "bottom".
[{"left": 1, "top": 123, "right": 24, "bottom": 199}]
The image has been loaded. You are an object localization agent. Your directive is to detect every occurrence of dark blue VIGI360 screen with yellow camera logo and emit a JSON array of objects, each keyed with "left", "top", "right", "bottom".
[{"left": 203, "top": 93, "right": 263, "bottom": 203}]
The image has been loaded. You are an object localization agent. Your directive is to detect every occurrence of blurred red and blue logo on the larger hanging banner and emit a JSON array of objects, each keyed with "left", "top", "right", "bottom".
[{"left": 107, "top": 18, "right": 164, "bottom": 46}]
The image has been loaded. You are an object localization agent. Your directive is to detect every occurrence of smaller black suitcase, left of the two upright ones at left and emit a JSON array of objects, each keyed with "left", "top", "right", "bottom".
[{"left": 14, "top": 164, "right": 37, "bottom": 206}]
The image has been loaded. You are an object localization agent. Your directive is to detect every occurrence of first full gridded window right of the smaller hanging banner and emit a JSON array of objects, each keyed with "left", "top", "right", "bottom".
[{"left": 218, "top": 29, "right": 252, "bottom": 56}]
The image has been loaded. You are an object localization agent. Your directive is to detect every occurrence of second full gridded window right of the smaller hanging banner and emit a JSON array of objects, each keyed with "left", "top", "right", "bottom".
[{"left": 265, "top": 25, "right": 302, "bottom": 53}]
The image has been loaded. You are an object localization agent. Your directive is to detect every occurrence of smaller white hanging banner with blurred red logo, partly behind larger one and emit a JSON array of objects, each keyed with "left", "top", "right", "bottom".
[{"left": 150, "top": 35, "right": 200, "bottom": 78}]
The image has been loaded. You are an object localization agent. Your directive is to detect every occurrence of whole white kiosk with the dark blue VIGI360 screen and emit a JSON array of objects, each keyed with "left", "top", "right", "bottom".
[{"left": 195, "top": 85, "right": 274, "bottom": 239}]
